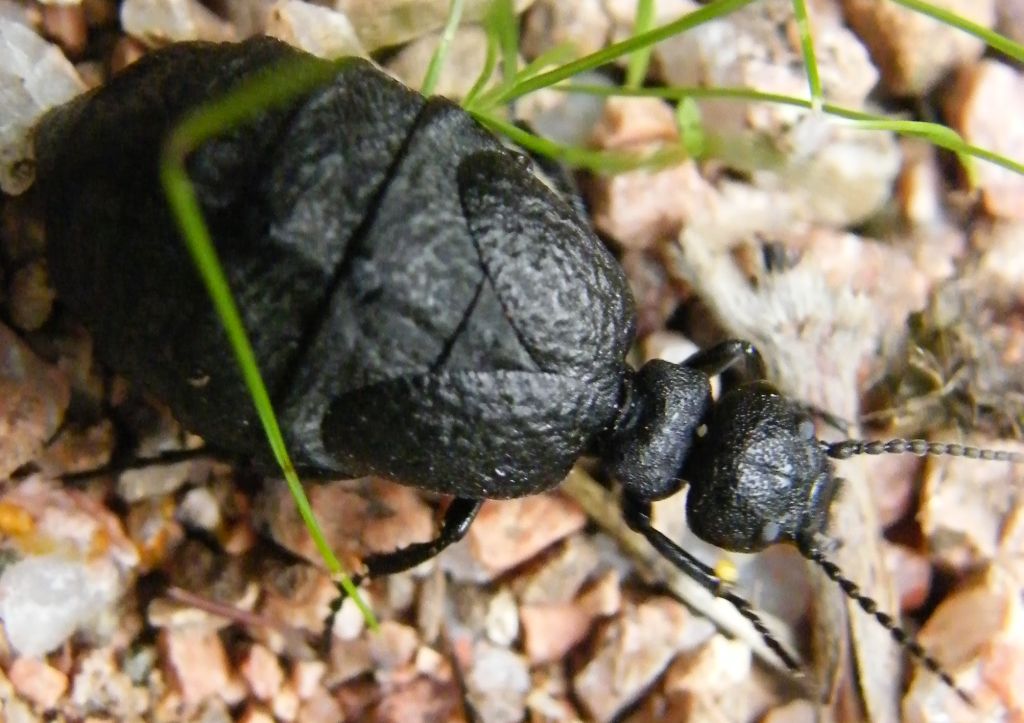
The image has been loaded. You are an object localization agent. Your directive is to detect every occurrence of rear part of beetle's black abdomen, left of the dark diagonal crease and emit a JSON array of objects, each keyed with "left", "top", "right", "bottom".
[{"left": 37, "top": 39, "right": 423, "bottom": 455}]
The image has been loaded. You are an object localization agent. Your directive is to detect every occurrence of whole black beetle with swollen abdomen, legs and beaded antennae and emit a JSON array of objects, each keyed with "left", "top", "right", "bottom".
[{"left": 37, "top": 39, "right": 1019, "bottom": 696}]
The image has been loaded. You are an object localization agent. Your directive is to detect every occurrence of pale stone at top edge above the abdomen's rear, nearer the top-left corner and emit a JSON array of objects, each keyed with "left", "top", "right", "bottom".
[{"left": 121, "top": 0, "right": 236, "bottom": 46}]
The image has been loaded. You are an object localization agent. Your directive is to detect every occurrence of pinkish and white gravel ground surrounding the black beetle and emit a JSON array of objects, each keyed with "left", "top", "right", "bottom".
[{"left": 0, "top": 0, "right": 1024, "bottom": 723}]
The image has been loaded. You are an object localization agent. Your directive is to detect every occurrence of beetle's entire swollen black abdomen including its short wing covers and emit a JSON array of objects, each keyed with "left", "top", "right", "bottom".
[{"left": 39, "top": 39, "right": 633, "bottom": 489}]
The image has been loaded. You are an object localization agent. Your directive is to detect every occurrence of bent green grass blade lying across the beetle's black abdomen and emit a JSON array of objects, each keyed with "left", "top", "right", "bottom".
[{"left": 160, "top": 58, "right": 378, "bottom": 629}]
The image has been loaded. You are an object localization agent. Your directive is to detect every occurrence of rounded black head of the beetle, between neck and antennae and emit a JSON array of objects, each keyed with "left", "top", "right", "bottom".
[{"left": 682, "top": 382, "right": 838, "bottom": 552}]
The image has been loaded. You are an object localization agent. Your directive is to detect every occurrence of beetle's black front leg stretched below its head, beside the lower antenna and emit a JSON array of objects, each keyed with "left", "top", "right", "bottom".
[{"left": 623, "top": 489, "right": 800, "bottom": 671}]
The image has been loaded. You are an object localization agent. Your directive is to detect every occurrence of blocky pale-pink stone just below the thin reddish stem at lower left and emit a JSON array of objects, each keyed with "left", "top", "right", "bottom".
[{"left": 160, "top": 627, "right": 231, "bottom": 706}]
